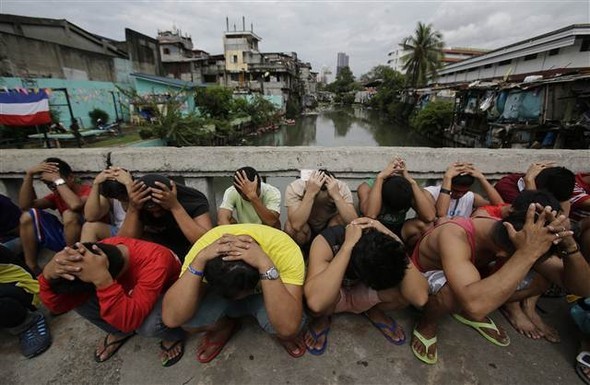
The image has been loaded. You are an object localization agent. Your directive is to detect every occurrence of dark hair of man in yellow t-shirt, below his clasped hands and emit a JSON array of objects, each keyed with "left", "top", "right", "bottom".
[{"left": 204, "top": 256, "right": 260, "bottom": 299}]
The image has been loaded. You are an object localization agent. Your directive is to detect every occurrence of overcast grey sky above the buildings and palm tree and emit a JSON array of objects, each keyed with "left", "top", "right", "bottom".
[{"left": 0, "top": 0, "right": 590, "bottom": 78}]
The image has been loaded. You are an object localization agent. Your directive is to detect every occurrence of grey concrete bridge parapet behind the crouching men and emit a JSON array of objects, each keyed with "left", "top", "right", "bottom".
[{"left": 0, "top": 147, "right": 590, "bottom": 221}]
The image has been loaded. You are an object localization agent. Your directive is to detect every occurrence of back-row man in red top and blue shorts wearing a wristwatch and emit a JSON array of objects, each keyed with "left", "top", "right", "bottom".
[{"left": 18, "top": 158, "right": 90, "bottom": 275}]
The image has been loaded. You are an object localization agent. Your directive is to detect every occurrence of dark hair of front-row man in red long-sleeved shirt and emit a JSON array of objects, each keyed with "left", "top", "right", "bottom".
[{"left": 49, "top": 242, "right": 125, "bottom": 294}]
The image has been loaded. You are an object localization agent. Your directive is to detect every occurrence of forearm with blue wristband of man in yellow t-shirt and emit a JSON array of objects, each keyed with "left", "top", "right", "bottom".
[{"left": 162, "top": 255, "right": 205, "bottom": 328}]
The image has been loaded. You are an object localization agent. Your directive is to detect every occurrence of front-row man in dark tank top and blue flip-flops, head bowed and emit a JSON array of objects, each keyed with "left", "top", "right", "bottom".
[{"left": 304, "top": 218, "right": 428, "bottom": 355}]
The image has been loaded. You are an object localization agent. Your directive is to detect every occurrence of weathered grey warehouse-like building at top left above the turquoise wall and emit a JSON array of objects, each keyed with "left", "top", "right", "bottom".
[{"left": 0, "top": 14, "right": 160, "bottom": 83}]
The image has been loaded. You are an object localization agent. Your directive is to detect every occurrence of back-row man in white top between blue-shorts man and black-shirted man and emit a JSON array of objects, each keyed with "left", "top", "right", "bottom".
[{"left": 80, "top": 166, "right": 133, "bottom": 242}]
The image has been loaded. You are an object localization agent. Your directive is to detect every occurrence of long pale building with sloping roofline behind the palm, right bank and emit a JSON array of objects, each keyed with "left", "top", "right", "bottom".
[{"left": 435, "top": 24, "right": 590, "bottom": 85}]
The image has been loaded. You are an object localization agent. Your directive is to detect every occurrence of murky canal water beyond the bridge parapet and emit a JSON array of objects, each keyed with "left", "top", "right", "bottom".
[{"left": 244, "top": 106, "right": 434, "bottom": 147}]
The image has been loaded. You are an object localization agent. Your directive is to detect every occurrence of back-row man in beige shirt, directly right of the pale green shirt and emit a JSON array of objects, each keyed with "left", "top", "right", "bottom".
[{"left": 284, "top": 169, "right": 358, "bottom": 246}]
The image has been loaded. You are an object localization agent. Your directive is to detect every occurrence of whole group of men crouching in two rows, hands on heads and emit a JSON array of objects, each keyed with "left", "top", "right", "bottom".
[{"left": 0, "top": 154, "right": 590, "bottom": 374}]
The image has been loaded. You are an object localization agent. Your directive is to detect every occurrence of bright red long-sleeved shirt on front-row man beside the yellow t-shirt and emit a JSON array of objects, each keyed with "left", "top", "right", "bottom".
[{"left": 39, "top": 237, "right": 180, "bottom": 333}]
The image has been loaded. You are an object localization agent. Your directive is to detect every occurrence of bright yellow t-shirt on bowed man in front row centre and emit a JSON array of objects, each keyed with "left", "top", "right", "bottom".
[{"left": 180, "top": 223, "right": 305, "bottom": 286}]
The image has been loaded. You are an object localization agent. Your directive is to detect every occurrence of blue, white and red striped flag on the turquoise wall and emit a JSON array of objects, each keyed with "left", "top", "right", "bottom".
[{"left": 0, "top": 90, "right": 51, "bottom": 126}]
